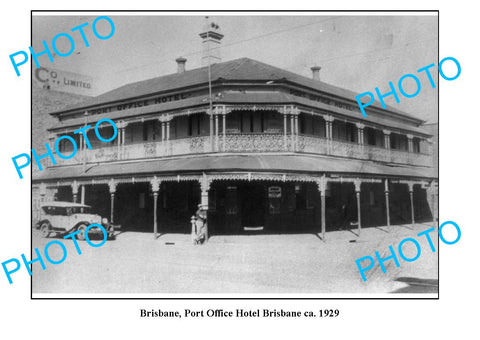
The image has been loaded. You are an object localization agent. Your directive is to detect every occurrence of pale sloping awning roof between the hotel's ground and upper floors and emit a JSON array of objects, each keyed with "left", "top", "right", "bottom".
[{"left": 33, "top": 154, "right": 435, "bottom": 182}]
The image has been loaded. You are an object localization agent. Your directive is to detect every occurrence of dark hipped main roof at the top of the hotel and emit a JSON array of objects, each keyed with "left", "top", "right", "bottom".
[{"left": 50, "top": 58, "right": 424, "bottom": 127}]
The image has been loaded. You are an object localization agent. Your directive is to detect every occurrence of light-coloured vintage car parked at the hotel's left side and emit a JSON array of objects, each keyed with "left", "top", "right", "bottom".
[{"left": 36, "top": 201, "right": 114, "bottom": 240}]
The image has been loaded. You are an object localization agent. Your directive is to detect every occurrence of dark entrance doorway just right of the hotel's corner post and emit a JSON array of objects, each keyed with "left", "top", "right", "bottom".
[{"left": 241, "top": 184, "right": 265, "bottom": 230}]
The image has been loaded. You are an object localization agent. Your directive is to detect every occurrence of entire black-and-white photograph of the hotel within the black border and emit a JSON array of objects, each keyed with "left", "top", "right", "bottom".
[{"left": 31, "top": 12, "right": 438, "bottom": 298}]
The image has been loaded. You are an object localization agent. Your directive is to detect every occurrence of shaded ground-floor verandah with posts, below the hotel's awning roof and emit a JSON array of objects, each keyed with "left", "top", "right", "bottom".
[{"left": 32, "top": 172, "right": 438, "bottom": 239}]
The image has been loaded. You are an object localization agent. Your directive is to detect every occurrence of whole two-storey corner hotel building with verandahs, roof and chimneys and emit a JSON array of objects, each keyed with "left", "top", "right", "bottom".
[{"left": 32, "top": 17, "right": 437, "bottom": 239}]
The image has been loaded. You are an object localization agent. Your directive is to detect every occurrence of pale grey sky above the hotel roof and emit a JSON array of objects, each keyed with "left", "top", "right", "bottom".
[{"left": 32, "top": 12, "right": 438, "bottom": 122}]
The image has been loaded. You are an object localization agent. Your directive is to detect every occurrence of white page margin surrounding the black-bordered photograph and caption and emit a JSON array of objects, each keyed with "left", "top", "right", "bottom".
[{"left": 0, "top": 0, "right": 480, "bottom": 339}]
